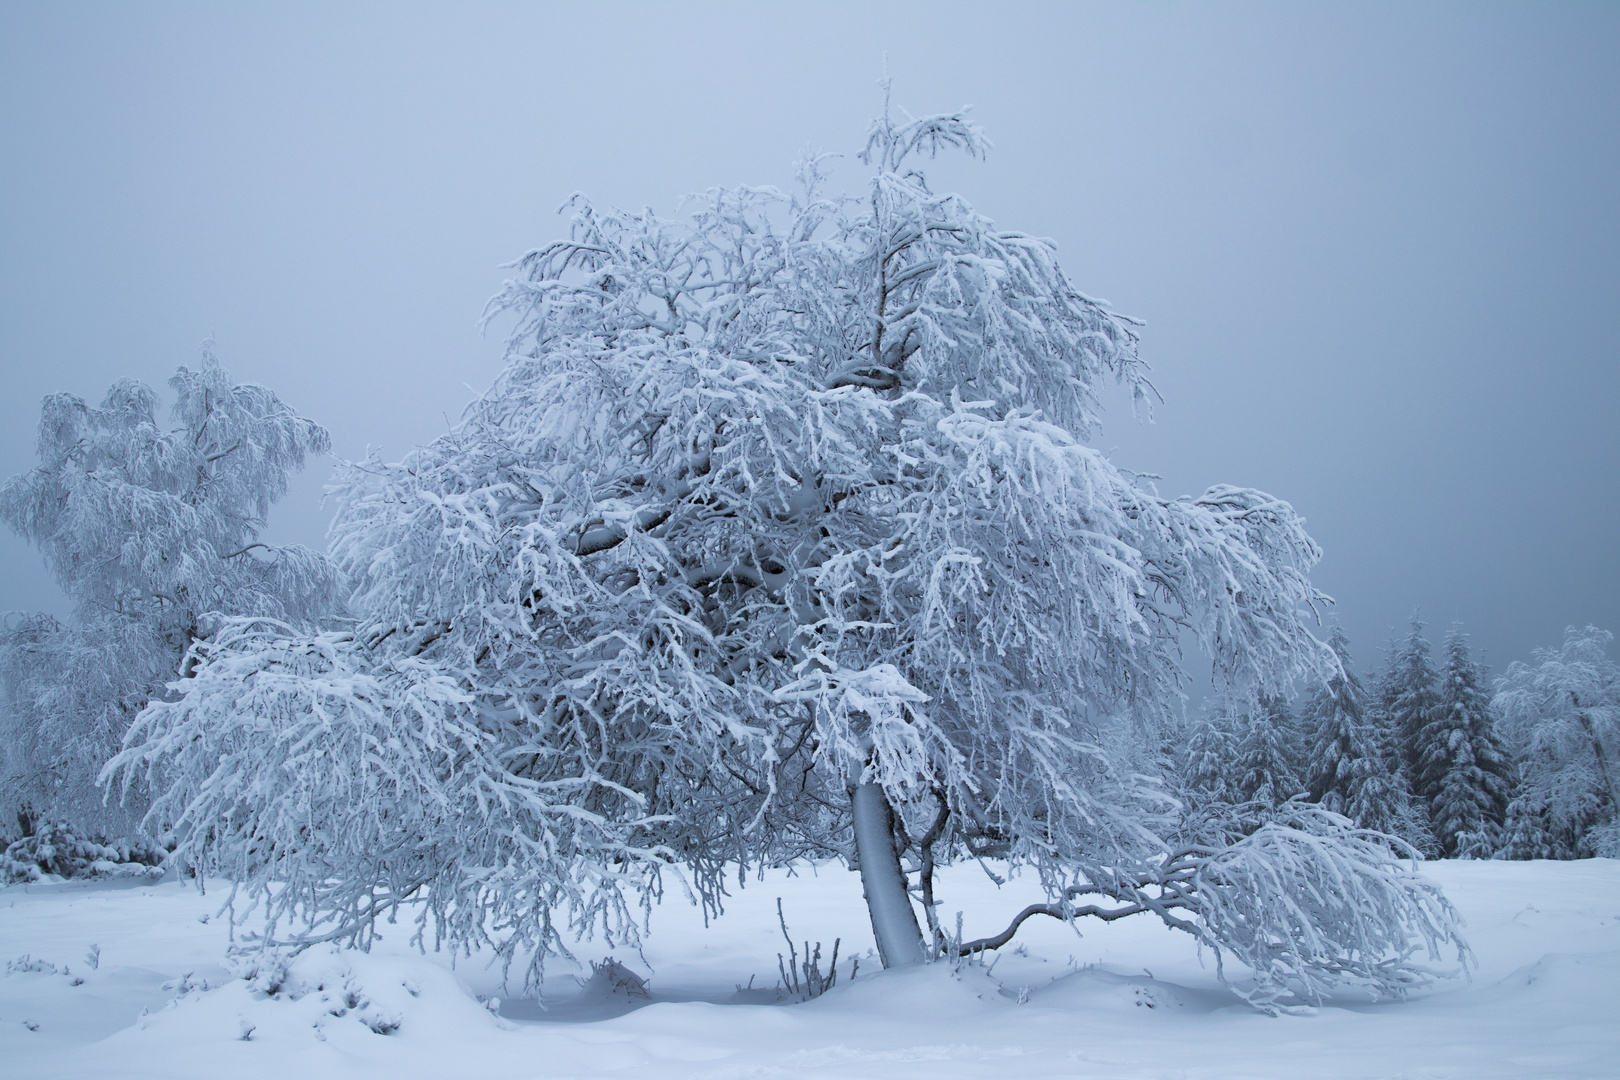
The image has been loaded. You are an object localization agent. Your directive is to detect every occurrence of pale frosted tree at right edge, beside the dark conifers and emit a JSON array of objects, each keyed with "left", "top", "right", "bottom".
[{"left": 1492, "top": 627, "right": 1620, "bottom": 857}]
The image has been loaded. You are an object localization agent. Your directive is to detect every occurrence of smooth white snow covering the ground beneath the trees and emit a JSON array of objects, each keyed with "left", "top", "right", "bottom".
[{"left": 0, "top": 860, "right": 1620, "bottom": 1080}]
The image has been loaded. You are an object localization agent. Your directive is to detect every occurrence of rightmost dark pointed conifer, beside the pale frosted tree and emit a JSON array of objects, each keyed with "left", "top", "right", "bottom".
[{"left": 1418, "top": 627, "right": 1513, "bottom": 858}]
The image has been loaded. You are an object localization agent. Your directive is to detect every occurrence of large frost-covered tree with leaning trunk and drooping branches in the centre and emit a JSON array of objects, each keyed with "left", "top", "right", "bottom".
[{"left": 115, "top": 105, "right": 1455, "bottom": 1002}]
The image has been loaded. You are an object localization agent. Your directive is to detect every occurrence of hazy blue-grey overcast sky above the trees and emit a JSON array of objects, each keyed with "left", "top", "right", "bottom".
[{"left": 0, "top": 2, "right": 1620, "bottom": 683}]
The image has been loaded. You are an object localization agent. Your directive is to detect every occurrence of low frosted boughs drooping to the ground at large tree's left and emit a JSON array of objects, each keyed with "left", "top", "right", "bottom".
[{"left": 104, "top": 619, "right": 661, "bottom": 962}]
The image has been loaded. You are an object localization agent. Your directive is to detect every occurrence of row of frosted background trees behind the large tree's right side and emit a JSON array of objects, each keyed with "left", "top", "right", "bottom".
[{"left": 1173, "top": 617, "right": 1620, "bottom": 860}]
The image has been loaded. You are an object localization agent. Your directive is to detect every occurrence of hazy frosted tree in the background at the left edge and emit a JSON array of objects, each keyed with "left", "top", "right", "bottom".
[{"left": 0, "top": 353, "right": 343, "bottom": 832}]
